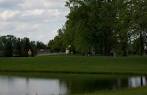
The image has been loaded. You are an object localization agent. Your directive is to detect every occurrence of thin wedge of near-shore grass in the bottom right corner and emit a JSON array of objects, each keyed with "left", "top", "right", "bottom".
[{"left": 75, "top": 87, "right": 147, "bottom": 95}]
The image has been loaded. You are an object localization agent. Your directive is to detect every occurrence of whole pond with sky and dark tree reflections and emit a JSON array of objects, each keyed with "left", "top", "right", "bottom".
[{"left": 0, "top": 76, "right": 147, "bottom": 95}]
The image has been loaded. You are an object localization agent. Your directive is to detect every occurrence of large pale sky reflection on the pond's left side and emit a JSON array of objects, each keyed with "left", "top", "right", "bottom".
[{"left": 0, "top": 77, "right": 67, "bottom": 95}]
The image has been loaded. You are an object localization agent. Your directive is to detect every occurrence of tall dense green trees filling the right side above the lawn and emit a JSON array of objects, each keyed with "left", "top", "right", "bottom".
[{"left": 49, "top": 0, "right": 147, "bottom": 56}]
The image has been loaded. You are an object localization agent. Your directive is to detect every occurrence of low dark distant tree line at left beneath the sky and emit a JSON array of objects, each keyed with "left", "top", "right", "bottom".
[{"left": 0, "top": 35, "right": 46, "bottom": 57}]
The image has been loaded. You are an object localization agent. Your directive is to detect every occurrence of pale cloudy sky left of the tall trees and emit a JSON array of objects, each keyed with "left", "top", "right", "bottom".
[{"left": 0, "top": 0, "right": 68, "bottom": 43}]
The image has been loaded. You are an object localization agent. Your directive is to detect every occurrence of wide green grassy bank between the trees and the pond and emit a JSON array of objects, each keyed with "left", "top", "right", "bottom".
[{"left": 0, "top": 56, "right": 147, "bottom": 74}]
